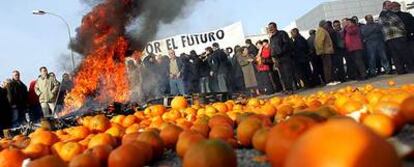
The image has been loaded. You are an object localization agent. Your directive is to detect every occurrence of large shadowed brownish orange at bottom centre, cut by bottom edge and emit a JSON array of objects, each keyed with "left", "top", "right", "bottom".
[{"left": 183, "top": 140, "right": 237, "bottom": 167}]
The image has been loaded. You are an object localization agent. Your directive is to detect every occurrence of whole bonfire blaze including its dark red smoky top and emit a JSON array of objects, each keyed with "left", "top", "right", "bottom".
[{"left": 59, "top": 0, "right": 131, "bottom": 116}]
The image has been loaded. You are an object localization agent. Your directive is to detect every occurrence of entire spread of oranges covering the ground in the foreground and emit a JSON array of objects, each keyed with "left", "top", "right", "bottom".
[{"left": 0, "top": 81, "right": 414, "bottom": 167}]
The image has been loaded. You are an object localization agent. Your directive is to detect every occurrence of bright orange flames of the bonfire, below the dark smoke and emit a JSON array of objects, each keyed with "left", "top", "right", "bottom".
[{"left": 61, "top": 37, "right": 129, "bottom": 115}]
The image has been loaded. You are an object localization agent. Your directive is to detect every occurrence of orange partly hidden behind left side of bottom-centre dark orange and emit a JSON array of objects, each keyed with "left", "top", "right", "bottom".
[{"left": 175, "top": 131, "right": 205, "bottom": 157}]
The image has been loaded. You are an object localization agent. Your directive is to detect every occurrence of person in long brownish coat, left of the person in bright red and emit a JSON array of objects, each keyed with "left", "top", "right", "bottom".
[{"left": 237, "top": 47, "right": 259, "bottom": 94}]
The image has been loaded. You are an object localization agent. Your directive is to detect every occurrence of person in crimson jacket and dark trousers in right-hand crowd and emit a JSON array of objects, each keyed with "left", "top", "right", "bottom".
[{"left": 344, "top": 19, "right": 367, "bottom": 80}]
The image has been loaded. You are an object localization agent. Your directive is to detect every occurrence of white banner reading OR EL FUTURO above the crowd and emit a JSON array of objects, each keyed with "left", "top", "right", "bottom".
[{"left": 144, "top": 22, "right": 245, "bottom": 56}]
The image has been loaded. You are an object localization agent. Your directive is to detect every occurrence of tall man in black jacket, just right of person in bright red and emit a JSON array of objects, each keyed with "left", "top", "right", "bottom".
[{"left": 268, "top": 22, "right": 294, "bottom": 94}]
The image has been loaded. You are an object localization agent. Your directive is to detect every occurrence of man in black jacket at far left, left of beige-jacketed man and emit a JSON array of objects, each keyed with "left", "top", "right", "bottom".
[{"left": 7, "top": 70, "right": 28, "bottom": 127}]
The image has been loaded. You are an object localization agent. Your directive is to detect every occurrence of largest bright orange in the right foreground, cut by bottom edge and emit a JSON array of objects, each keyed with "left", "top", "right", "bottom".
[{"left": 284, "top": 119, "right": 402, "bottom": 167}]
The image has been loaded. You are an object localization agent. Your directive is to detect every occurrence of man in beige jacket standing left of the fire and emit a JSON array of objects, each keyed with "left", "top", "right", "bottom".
[{"left": 35, "top": 67, "right": 59, "bottom": 117}]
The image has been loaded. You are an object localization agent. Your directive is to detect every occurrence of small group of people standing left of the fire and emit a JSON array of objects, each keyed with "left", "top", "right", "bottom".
[{"left": 0, "top": 67, "right": 73, "bottom": 129}]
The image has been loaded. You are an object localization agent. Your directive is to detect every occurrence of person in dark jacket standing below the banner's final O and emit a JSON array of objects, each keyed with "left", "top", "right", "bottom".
[{"left": 209, "top": 43, "right": 231, "bottom": 92}]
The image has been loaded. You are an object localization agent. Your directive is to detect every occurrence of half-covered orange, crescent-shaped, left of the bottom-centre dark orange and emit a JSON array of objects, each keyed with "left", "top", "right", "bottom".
[{"left": 137, "top": 131, "right": 164, "bottom": 159}]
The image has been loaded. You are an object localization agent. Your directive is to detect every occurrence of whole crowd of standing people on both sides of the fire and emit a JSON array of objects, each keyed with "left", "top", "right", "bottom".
[{"left": 0, "top": 1, "right": 414, "bottom": 131}]
